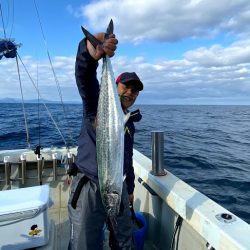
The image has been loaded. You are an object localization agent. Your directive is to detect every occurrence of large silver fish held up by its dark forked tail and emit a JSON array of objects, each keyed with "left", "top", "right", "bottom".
[{"left": 82, "top": 20, "right": 129, "bottom": 217}]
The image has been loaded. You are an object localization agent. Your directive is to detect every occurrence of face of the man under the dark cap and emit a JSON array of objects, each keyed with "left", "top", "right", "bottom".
[{"left": 117, "top": 82, "right": 139, "bottom": 110}]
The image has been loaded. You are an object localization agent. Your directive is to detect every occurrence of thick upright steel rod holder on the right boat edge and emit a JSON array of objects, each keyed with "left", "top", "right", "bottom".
[{"left": 151, "top": 131, "right": 167, "bottom": 176}]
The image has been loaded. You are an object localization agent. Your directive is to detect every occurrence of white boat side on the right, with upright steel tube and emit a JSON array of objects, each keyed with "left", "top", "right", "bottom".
[{"left": 133, "top": 132, "right": 250, "bottom": 250}]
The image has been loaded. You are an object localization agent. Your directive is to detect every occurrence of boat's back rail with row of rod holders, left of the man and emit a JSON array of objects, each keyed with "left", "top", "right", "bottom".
[{"left": 0, "top": 146, "right": 76, "bottom": 189}]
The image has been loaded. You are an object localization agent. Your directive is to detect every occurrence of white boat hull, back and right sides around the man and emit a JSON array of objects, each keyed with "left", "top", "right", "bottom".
[{"left": 0, "top": 149, "right": 250, "bottom": 250}]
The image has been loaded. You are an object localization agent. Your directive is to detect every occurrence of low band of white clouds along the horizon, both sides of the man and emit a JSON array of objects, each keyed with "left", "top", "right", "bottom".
[{"left": 0, "top": 36, "right": 250, "bottom": 104}]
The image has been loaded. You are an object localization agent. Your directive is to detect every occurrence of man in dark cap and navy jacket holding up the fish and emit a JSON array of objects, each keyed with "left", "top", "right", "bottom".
[{"left": 68, "top": 30, "right": 143, "bottom": 250}]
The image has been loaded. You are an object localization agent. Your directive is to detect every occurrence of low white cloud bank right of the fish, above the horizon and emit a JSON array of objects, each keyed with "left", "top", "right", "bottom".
[{"left": 110, "top": 41, "right": 250, "bottom": 104}]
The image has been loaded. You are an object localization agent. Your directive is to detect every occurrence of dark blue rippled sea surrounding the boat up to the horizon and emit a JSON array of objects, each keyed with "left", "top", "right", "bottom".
[{"left": 0, "top": 104, "right": 250, "bottom": 224}]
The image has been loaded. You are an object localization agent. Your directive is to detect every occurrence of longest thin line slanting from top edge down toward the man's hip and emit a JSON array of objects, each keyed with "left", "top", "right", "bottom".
[{"left": 34, "top": 0, "right": 75, "bottom": 146}]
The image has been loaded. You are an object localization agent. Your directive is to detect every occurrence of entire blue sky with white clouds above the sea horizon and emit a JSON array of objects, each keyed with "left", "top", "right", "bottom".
[{"left": 0, "top": 0, "right": 250, "bottom": 104}]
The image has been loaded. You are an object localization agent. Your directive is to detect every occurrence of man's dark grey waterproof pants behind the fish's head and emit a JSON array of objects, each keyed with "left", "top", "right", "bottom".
[{"left": 68, "top": 173, "right": 134, "bottom": 250}]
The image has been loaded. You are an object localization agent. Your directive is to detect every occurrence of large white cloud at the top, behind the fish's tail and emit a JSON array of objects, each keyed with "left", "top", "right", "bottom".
[{"left": 71, "top": 0, "right": 250, "bottom": 43}]
